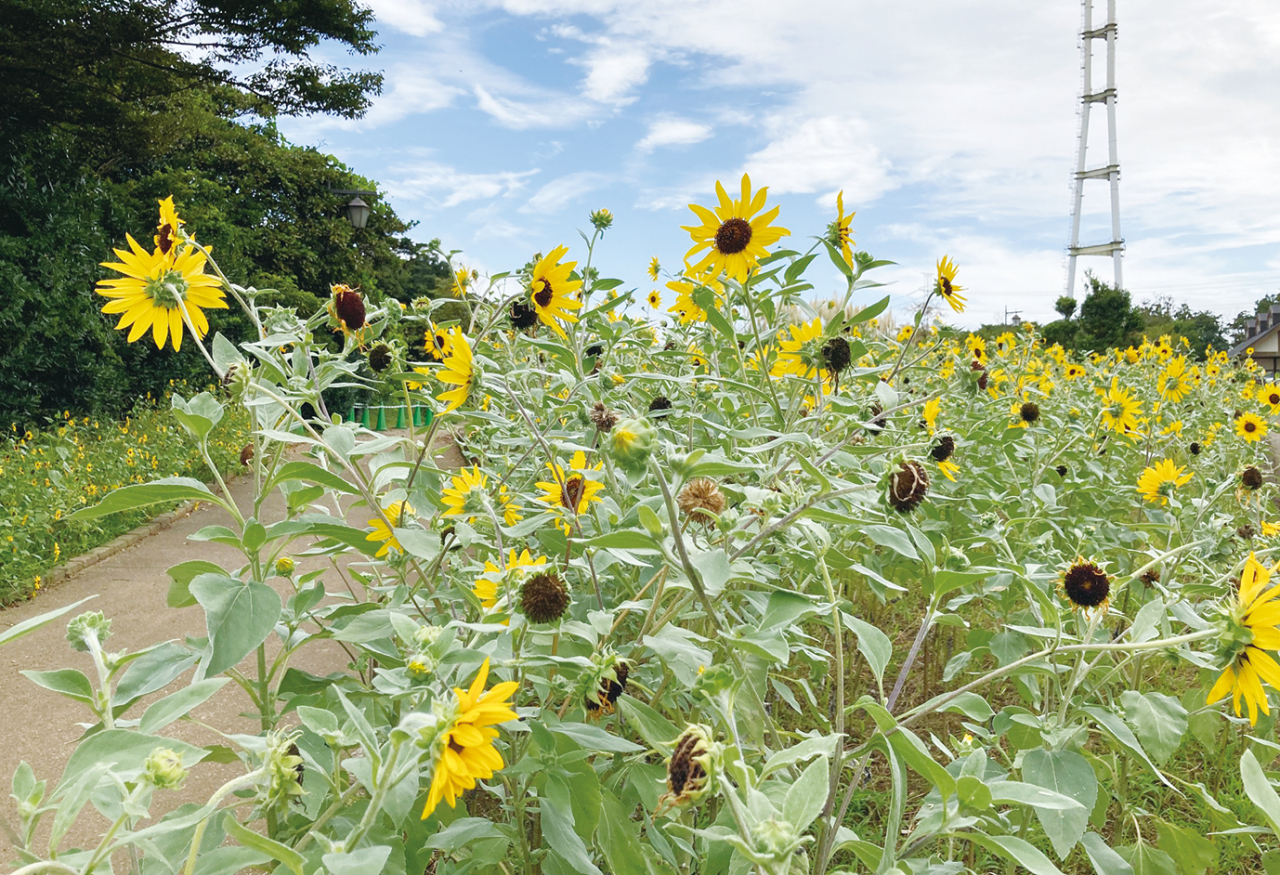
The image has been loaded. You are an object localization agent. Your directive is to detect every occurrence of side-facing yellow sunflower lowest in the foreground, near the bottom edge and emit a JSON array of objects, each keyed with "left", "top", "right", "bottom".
[{"left": 422, "top": 659, "right": 520, "bottom": 820}]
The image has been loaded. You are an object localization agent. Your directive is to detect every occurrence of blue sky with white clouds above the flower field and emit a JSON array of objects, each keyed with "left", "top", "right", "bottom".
[{"left": 280, "top": 0, "right": 1280, "bottom": 327}]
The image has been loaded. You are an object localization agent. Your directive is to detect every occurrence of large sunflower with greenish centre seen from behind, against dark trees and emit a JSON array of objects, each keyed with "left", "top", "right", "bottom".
[{"left": 96, "top": 235, "right": 227, "bottom": 352}]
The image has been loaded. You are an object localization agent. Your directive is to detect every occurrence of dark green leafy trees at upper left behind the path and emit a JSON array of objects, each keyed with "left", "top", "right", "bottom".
[{"left": 0, "top": 0, "right": 452, "bottom": 431}]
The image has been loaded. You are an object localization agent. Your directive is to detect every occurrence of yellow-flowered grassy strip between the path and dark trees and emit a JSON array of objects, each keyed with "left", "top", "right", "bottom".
[{"left": 0, "top": 382, "right": 248, "bottom": 606}]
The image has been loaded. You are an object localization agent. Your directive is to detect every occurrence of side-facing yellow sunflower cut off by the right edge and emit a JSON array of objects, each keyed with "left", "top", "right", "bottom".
[{"left": 1204, "top": 553, "right": 1280, "bottom": 724}]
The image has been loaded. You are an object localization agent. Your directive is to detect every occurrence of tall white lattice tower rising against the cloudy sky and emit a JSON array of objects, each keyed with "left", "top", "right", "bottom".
[{"left": 1066, "top": 0, "right": 1124, "bottom": 298}]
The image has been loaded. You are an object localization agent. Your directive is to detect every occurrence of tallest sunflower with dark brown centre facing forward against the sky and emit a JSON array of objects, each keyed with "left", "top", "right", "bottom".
[{"left": 682, "top": 173, "right": 791, "bottom": 283}]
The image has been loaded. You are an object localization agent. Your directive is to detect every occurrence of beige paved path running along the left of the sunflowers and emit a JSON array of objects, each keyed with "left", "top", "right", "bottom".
[{"left": 0, "top": 434, "right": 457, "bottom": 867}]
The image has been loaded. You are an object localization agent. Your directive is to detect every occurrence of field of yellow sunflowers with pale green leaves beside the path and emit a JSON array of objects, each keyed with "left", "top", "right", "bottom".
[{"left": 12, "top": 177, "right": 1280, "bottom": 875}]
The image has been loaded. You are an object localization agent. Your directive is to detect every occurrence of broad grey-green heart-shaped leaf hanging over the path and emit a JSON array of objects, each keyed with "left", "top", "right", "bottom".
[{"left": 191, "top": 574, "right": 284, "bottom": 677}]
